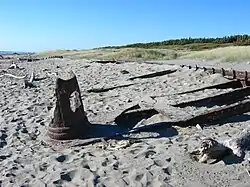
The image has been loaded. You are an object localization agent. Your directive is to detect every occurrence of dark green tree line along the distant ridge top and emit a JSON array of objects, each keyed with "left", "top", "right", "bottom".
[{"left": 101, "top": 34, "right": 250, "bottom": 48}]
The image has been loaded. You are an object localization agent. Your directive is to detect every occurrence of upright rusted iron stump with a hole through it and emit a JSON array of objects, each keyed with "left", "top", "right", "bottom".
[{"left": 48, "top": 71, "right": 90, "bottom": 140}]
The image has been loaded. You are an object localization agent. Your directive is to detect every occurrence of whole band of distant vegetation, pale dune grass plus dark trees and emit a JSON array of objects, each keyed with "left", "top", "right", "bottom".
[{"left": 34, "top": 35, "right": 250, "bottom": 62}]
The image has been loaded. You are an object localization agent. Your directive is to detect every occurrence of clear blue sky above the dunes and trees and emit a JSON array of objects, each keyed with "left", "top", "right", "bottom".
[{"left": 0, "top": 0, "right": 250, "bottom": 51}]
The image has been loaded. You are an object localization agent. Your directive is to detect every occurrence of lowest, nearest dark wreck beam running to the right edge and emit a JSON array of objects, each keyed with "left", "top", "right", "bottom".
[{"left": 169, "top": 100, "right": 250, "bottom": 127}]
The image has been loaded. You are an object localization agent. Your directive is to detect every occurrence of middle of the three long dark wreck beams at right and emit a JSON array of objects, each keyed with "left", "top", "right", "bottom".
[{"left": 173, "top": 87, "right": 250, "bottom": 108}]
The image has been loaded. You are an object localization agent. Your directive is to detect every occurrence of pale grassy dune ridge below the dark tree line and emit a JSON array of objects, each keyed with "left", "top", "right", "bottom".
[{"left": 34, "top": 46, "right": 250, "bottom": 62}]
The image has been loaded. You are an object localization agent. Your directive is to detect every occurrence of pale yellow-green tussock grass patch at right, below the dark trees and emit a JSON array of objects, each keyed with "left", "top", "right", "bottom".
[{"left": 180, "top": 46, "right": 250, "bottom": 62}]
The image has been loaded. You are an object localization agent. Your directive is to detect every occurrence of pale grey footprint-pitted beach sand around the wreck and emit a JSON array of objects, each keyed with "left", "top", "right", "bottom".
[{"left": 0, "top": 59, "right": 250, "bottom": 187}]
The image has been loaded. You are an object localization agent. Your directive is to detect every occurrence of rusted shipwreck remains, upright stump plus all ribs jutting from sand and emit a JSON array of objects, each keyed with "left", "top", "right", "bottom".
[{"left": 48, "top": 62, "right": 250, "bottom": 145}]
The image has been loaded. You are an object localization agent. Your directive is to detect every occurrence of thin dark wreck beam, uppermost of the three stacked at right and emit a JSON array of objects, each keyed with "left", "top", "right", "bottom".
[{"left": 177, "top": 80, "right": 243, "bottom": 95}]
